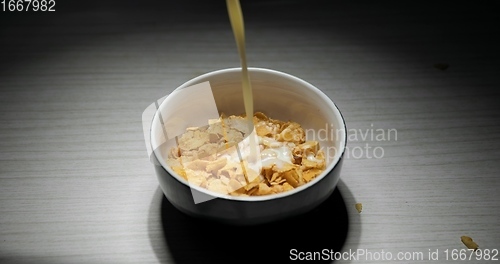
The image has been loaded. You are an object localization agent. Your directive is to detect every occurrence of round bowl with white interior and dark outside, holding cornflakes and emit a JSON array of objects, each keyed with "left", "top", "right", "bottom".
[{"left": 150, "top": 68, "right": 347, "bottom": 225}]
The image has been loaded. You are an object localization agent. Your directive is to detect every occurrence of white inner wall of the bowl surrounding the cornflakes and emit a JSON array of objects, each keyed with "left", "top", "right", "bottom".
[{"left": 151, "top": 68, "right": 346, "bottom": 200}]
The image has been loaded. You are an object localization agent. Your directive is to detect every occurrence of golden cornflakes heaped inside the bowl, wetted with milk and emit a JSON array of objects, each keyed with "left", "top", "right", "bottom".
[{"left": 167, "top": 112, "right": 326, "bottom": 196}]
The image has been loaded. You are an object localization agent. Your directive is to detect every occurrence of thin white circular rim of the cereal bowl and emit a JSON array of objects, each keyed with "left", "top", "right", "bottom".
[{"left": 149, "top": 67, "right": 347, "bottom": 202}]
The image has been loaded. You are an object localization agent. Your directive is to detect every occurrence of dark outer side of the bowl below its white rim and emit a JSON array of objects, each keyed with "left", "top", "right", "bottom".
[{"left": 152, "top": 155, "right": 343, "bottom": 225}]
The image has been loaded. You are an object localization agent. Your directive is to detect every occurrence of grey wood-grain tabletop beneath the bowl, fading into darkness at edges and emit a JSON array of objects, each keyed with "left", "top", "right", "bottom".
[{"left": 0, "top": 0, "right": 500, "bottom": 264}]
